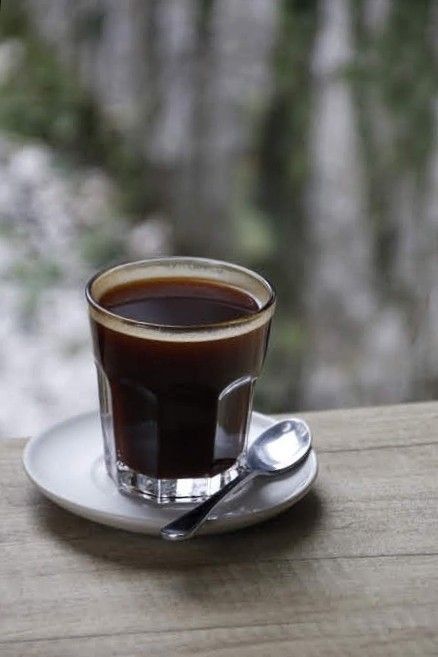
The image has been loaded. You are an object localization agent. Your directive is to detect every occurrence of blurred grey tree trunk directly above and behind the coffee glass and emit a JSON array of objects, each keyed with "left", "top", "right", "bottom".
[{"left": 171, "top": 0, "right": 276, "bottom": 258}]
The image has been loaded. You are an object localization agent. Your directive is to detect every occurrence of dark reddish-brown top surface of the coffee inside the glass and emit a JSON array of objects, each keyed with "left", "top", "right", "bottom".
[{"left": 100, "top": 278, "right": 258, "bottom": 327}]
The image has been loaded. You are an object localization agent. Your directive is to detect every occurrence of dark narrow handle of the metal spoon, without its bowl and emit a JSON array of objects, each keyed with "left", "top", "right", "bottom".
[{"left": 161, "top": 470, "right": 255, "bottom": 541}]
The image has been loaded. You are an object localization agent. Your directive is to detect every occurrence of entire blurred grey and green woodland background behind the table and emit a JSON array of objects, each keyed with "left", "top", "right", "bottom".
[{"left": 0, "top": 0, "right": 438, "bottom": 436}]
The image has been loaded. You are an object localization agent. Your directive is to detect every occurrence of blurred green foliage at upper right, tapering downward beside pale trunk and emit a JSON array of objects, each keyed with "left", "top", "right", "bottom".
[{"left": 346, "top": 0, "right": 438, "bottom": 296}]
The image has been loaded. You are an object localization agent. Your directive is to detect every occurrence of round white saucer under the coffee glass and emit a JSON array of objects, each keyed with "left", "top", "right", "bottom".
[{"left": 23, "top": 412, "right": 318, "bottom": 535}]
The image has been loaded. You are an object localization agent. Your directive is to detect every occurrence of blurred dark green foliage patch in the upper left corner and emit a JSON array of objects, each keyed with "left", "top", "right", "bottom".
[{"left": 0, "top": 3, "right": 155, "bottom": 215}]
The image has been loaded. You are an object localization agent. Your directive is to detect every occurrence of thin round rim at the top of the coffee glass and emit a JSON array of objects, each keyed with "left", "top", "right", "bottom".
[{"left": 85, "top": 256, "right": 276, "bottom": 335}]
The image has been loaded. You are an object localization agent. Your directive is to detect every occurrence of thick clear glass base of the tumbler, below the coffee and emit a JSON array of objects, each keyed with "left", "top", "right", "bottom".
[{"left": 113, "top": 460, "right": 243, "bottom": 504}]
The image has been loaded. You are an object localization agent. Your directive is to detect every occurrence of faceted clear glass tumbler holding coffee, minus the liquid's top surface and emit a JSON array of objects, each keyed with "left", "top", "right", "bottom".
[{"left": 86, "top": 257, "right": 275, "bottom": 504}]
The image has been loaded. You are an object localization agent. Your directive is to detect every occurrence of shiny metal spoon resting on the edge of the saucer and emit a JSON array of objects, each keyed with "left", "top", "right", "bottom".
[{"left": 161, "top": 418, "right": 312, "bottom": 541}]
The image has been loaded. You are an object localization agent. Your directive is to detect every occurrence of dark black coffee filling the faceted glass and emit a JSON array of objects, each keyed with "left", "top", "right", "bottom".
[{"left": 92, "top": 278, "right": 269, "bottom": 479}]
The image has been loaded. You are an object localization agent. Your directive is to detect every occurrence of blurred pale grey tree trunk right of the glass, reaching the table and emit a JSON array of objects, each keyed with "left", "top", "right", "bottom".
[{"left": 303, "top": 0, "right": 396, "bottom": 407}]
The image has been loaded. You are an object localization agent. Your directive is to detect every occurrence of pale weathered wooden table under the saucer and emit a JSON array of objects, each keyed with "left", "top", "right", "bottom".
[{"left": 0, "top": 403, "right": 438, "bottom": 657}]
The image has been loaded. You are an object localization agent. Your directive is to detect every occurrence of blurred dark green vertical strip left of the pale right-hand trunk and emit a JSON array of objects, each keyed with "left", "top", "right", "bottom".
[{"left": 246, "top": 0, "right": 317, "bottom": 412}]
